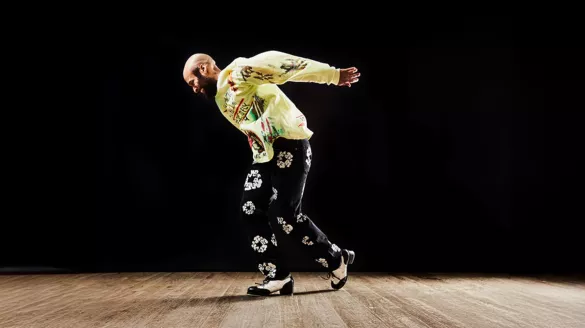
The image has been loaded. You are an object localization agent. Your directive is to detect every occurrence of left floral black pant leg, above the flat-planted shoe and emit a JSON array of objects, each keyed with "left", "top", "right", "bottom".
[{"left": 240, "top": 164, "right": 289, "bottom": 279}]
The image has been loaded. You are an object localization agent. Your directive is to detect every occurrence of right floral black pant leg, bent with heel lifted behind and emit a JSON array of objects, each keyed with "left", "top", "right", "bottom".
[{"left": 268, "top": 138, "right": 341, "bottom": 271}]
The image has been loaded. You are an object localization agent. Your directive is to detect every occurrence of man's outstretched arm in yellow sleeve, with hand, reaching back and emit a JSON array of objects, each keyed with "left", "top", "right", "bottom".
[{"left": 235, "top": 51, "right": 359, "bottom": 86}]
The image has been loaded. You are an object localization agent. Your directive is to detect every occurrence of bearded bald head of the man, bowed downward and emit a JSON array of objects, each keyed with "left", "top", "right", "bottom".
[{"left": 183, "top": 53, "right": 221, "bottom": 98}]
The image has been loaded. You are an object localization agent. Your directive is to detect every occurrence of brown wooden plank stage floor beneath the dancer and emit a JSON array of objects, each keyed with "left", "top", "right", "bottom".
[{"left": 0, "top": 272, "right": 585, "bottom": 328}]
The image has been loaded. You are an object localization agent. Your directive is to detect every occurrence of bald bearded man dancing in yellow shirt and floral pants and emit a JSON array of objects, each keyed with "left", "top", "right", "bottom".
[{"left": 183, "top": 51, "right": 360, "bottom": 295}]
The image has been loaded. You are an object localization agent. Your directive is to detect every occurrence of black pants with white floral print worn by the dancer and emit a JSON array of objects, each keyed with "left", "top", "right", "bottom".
[{"left": 240, "top": 138, "right": 341, "bottom": 279}]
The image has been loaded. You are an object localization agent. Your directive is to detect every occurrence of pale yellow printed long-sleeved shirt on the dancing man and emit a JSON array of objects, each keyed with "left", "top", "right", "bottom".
[{"left": 215, "top": 51, "right": 339, "bottom": 163}]
